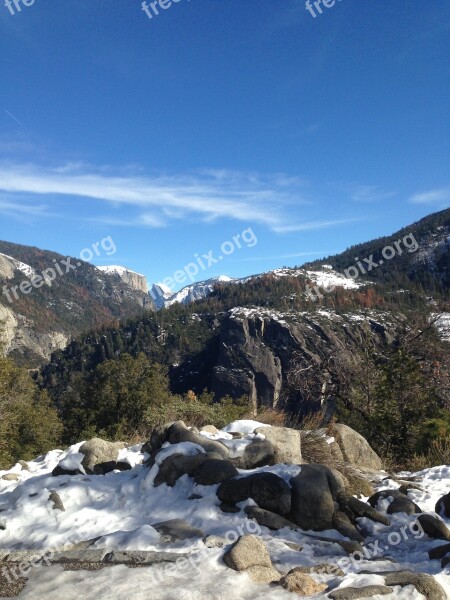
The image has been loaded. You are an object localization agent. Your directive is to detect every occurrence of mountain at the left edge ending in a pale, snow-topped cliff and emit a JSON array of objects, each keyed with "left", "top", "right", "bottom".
[{"left": 0, "top": 241, "right": 153, "bottom": 367}]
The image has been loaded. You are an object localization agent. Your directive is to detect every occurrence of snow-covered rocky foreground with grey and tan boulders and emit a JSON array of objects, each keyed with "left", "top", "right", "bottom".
[{"left": 0, "top": 421, "right": 450, "bottom": 600}]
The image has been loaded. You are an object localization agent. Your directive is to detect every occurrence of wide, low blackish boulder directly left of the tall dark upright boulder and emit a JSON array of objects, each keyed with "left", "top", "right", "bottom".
[{"left": 217, "top": 473, "right": 291, "bottom": 515}]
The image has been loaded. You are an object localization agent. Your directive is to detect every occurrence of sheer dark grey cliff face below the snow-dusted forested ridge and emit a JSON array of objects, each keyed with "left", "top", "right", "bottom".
[{"left": 211, "top": 308, "right": 395, "bottom": 408}]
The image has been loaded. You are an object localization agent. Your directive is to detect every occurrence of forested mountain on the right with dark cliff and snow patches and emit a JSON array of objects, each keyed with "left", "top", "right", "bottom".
[{"left": 39, "top": 211, "right": 450, "bottom": 424}]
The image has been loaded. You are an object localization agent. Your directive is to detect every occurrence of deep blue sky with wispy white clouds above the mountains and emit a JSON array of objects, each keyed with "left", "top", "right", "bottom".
[{"left": 0, "top": 0, "right": 450, "bottom": 290}]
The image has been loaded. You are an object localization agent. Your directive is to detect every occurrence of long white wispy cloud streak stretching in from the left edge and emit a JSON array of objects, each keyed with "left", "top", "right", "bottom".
[{"left": 0, "top": 164, "right": 307, "bottom": 231}]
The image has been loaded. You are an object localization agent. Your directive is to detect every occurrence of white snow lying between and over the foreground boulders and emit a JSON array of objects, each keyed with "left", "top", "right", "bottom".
[{"left": 0, "top": 421, "right": 450, "bottom": 600}]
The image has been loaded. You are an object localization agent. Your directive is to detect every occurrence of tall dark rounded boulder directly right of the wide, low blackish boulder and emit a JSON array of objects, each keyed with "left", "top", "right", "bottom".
[{"left": 290, "top": 465, "right": 342, "bottom": 531}]
